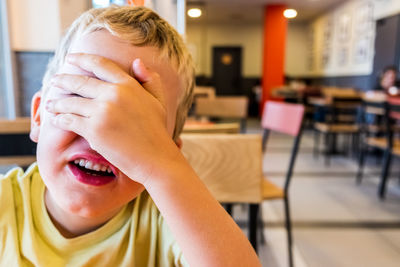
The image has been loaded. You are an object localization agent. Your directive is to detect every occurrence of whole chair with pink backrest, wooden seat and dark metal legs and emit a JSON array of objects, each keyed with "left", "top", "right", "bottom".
[{"left": 261, "top": 101, "right": 305, "bottom": 266}]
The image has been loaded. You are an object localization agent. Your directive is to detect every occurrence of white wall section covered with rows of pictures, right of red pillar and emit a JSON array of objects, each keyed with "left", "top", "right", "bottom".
[{"left": 309, "top": 0, "right": 376, "bottom": 76}]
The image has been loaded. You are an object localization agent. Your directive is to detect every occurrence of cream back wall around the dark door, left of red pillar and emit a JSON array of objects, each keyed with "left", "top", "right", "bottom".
[{"left": 186, "top": 23, "right": 263, "bottom": 77}]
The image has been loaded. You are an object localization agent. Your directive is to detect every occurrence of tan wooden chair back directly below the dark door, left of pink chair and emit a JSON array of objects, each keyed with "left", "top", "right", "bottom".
[{"left": 195, "top": 96, "right": 249, "bottom": 132}]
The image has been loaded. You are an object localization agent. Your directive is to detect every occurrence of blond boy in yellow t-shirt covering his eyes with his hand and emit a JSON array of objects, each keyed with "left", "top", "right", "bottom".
[{"left": 0, "top": 6, "right": 260, "bottom": 267}]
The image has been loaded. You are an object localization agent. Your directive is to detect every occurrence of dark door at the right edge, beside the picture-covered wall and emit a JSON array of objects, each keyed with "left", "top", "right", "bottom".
[{"left": 371, "top": 15, "right": 400, "bottom": 85}]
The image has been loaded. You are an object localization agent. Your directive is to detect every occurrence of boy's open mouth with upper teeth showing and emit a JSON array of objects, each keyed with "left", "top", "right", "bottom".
[{"left": 68, "top": 158, "right": 117, "bottom": 186}]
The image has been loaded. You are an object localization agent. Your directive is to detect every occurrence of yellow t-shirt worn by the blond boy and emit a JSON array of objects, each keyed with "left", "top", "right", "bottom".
[{"left": 0, "top": 164, "right": 188, "bottom": 267}]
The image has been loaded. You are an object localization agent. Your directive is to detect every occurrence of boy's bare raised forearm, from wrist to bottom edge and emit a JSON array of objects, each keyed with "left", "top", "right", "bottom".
[{"left": 145, "top": 151, "right": 261, "bottom": 266}]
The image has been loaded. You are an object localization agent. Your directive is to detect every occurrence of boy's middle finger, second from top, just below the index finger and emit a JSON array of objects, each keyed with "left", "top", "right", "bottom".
[{"left": 51, "top": 74, "right": 108, "bottom": 98}]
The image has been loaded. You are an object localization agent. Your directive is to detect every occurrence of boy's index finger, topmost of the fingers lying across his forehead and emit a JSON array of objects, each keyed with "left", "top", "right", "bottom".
[{"left": 66, "top": 53, "right": 131, "bottom": 83}]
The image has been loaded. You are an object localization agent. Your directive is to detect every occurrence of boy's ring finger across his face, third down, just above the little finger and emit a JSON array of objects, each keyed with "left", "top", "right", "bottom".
[{"left": 45, "top": 97, "right": 95, "bottom": 117}]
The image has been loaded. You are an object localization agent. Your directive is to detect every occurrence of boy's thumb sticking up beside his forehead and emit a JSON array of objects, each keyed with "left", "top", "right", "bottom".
[{"left": 132, "top": 58, "right": 165, "bottom": 106}]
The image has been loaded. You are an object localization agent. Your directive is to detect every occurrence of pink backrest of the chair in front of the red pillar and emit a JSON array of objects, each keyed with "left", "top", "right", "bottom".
[{"left": 261, "top": 101, "right": 304, "bottom": 136}]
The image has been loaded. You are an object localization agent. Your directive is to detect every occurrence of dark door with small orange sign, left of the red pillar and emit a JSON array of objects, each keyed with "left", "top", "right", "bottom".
[{"left": 213, "top": 47, "right": 242, "bottom": 95}]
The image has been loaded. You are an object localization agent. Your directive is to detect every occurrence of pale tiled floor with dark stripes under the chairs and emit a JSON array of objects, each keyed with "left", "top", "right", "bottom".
[{"left": 244, "top": 121, "right": 400, "bottom": 267}]
